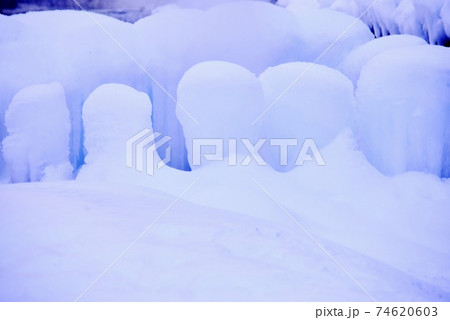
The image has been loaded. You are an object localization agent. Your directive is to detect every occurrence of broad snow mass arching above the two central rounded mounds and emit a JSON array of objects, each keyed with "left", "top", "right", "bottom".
[{"left": 135, "top": 2, "right": 305, "bottom": 169}]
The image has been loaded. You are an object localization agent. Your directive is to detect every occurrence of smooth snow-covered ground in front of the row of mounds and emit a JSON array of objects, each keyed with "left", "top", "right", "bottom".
[{"left": 0, "top": 130, "right": 450, "bottom": 301}]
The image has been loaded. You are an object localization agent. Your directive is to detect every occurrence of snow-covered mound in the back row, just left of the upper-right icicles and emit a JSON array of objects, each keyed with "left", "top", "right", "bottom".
[{"left": 297, "top": 9, "right": 373, "bottom": 67}]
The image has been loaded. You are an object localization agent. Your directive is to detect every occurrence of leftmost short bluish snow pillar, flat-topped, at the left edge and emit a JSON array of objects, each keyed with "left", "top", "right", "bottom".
[{"left": 3, "top": 83, "right": 73, "bottom": 182}]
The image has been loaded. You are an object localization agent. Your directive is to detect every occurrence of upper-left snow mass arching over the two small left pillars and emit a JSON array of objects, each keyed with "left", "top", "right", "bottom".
[{"left": 0, "top": 10, "right": 142, "bottom": 176}]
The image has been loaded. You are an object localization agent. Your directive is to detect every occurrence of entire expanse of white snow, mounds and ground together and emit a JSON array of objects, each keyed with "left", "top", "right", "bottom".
[{"left": 0, "top": 0, "right": 450, "bottom": 301}]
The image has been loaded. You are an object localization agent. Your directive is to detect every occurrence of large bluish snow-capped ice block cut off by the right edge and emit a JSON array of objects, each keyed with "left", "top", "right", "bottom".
[{"left": 356, "top": 46, "right": 450, "bottom": 176}]
